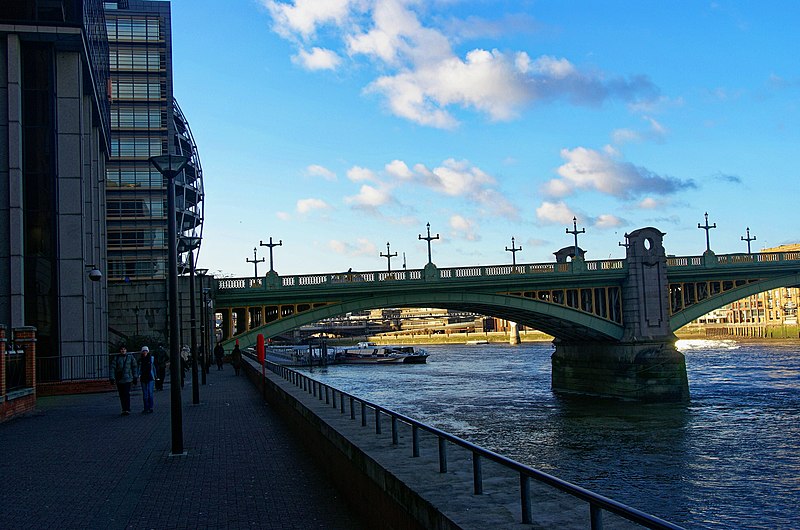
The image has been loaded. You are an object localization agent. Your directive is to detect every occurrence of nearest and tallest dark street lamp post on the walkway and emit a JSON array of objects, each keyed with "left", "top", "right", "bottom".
[{"left": 150, "top": 154, "right": 189, "bottom": 455}]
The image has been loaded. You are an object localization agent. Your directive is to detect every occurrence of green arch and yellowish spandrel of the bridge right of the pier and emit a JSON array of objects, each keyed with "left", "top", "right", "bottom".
[{"left": 670, "top": 274, "right": 800, "bottom": 332}]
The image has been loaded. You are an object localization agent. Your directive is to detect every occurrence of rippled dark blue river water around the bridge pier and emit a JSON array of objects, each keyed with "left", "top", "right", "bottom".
[{"left": 298, "top": 341, "right": 800, "bottom": 529}]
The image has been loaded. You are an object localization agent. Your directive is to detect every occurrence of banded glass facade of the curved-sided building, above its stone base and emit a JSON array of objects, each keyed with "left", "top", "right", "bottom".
[{"left": 104, "top": 0, "right": 203, "bottom": 282}]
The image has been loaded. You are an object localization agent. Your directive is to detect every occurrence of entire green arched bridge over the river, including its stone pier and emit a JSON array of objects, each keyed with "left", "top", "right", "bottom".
[{"left": 216, "top": 227, "right": 800, "bottom": 401}]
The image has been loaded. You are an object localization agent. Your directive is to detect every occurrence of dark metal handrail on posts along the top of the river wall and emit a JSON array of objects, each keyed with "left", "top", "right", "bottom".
[{"left": 260, "top": 353, "right": 682, "bottom": 530}]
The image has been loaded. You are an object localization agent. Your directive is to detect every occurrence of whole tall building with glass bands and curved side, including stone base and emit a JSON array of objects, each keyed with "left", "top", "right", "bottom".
[{"left": 104, "top": 0, "right": 204, "bottom": 343}]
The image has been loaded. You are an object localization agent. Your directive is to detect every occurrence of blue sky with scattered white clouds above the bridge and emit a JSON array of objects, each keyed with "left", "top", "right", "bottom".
[{"left": 167, "top": 0, "right": 800, "bottom": 276}]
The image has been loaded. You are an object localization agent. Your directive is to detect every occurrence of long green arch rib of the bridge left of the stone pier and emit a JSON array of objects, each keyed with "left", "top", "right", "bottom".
[{"left": 225, "top": 292, "right": 623, "bottom": 346}]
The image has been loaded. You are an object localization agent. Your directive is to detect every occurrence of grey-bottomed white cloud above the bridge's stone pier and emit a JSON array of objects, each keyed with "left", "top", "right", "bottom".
[{"left": 542, "top": 147, "right": 695, "bottom": 199}]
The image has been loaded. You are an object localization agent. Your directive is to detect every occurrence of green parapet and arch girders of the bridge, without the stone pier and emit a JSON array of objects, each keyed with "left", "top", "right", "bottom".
[{"left": 216, "top": 252, "right": 800, "bottom": 347}]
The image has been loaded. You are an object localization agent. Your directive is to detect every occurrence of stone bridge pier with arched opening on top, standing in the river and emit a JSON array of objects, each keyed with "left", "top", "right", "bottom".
[{"left": 552, "top": 227, "right": 689, "bottom": 402}]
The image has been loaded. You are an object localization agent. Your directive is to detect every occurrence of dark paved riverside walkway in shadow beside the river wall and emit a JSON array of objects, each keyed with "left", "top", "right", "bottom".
[{"left": 0, "top": 366, "right": 363, "bottom": 530}]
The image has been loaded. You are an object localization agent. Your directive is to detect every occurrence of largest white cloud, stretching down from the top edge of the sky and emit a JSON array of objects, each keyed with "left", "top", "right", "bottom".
[{"left": 262, "top": 0, "right": 658, "bottom": 129}]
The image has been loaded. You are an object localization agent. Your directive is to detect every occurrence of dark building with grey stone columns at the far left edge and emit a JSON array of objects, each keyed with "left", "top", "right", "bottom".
[{"left": 0, "top": 0, "right": 110, "bottom": 356}]
